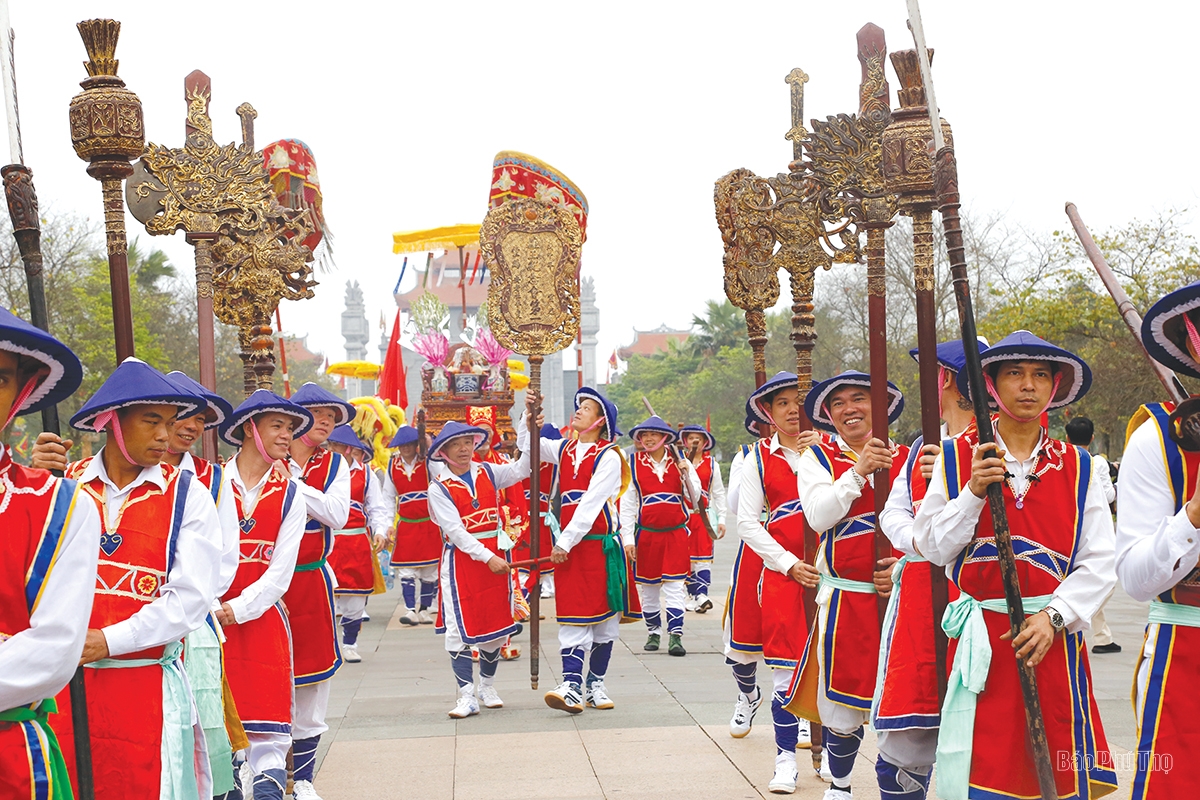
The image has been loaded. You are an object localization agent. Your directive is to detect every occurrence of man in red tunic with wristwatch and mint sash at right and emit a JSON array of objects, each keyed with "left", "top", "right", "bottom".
[{"left": 914, "top": 331, "right": 1116, "bottom": 800}]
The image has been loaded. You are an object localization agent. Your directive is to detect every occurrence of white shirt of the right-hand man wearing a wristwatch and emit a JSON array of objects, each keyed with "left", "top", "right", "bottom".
[{"left": 913, "top": 432, "right": 1116, "bottom": 633}]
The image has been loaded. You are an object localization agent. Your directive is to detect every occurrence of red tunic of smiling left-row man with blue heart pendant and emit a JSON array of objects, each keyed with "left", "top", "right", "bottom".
[{"left": 221, "top": 470, "right": 297, "bottom": 733}]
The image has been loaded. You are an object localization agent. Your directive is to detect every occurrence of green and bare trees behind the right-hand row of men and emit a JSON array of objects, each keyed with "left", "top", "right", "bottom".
[{"left": 608, "top": 211, "right": 1200, "bottom": 463}]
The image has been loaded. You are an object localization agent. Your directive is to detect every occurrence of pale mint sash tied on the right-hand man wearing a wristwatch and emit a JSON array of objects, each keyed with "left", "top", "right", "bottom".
[{"left": 937, "top": 593, "right": 1051, "bottom": 800}]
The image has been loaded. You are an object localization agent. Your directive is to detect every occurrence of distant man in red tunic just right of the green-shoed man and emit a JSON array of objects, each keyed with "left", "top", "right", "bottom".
[{"left": 679, "top": 425, "right": 725, "bottom": 614}]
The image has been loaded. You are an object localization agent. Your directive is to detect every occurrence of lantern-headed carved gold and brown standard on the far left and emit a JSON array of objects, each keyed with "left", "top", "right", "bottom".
[{"left": 70, "top": 19, "right": 145, "bottom": 363}]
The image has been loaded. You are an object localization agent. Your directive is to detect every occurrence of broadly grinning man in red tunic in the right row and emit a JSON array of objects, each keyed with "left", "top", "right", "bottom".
[{"left": 792, "top": 372, "right": 908, "bottom": 800}]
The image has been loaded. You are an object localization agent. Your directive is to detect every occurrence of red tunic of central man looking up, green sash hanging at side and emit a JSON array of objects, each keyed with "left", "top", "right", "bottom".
[{"left": 554, "top": 439, "right": 628, "bottom": 625}]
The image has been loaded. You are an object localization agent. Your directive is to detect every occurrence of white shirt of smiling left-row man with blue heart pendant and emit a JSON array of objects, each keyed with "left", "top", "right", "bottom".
[{"left": 224, "top": 458, "right": 308, "bottom": 622}]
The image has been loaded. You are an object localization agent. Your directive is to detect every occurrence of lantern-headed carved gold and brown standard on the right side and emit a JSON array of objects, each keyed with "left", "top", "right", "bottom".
[{"left": 883, "top": 45, "right": 953, "bottom": 698}]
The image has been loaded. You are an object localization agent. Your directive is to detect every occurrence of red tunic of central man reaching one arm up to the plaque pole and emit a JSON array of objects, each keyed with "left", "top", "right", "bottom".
[{"left": 430, "top": 464, "right": 517, "bottom": 644}]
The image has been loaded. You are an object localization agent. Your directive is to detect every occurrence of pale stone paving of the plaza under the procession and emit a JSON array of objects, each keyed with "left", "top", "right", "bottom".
[{"left": 316, "top": 539, "right": 1146, "bottom": 800}]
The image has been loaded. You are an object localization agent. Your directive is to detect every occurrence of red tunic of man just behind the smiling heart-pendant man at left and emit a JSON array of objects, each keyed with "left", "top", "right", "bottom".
[{"left": 283, "top": 450, "right": 342, "bottom": 686}]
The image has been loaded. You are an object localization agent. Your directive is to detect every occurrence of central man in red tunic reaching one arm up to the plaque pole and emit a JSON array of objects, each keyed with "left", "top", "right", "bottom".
[{"left": 430, "top": 419, "right": 533, "bottom": 718}]
